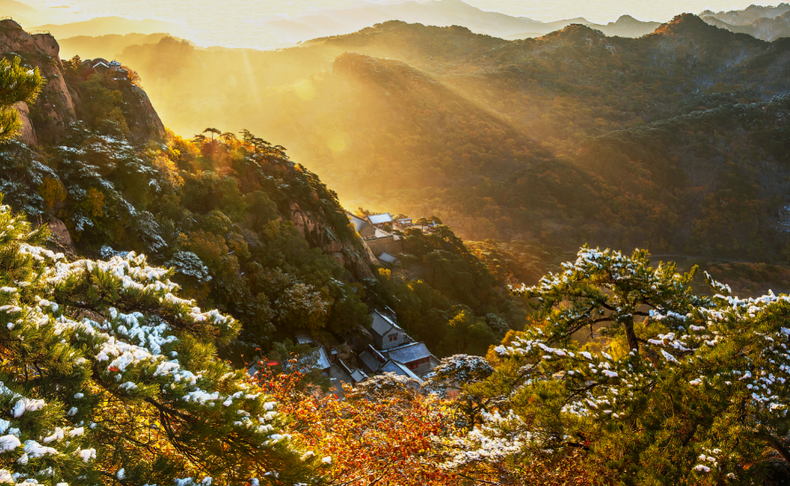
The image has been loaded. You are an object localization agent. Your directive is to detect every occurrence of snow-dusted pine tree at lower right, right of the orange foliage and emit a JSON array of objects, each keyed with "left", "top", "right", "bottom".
[{"left": 460, "top": 248, "right": 790, "bottom": 484}]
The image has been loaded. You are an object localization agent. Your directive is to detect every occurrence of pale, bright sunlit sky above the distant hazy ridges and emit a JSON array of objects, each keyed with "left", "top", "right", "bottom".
[{"left": 29, "top": 0, "right": 772, "bottom": 45}]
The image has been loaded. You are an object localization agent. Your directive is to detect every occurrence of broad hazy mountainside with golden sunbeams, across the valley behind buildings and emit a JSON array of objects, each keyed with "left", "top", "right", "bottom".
[{"left": 103, "top": 15, "right": 790, "bottom": 266}]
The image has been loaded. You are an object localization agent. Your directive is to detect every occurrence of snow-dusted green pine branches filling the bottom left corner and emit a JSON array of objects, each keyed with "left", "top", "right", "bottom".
[{"left": 0, "top": 198, "right": 315, "bottom": 485}]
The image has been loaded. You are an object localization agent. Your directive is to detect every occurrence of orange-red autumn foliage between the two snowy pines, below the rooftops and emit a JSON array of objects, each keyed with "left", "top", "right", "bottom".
[{"left": 259, "top": 361, "right": 459, "bottom": 486}]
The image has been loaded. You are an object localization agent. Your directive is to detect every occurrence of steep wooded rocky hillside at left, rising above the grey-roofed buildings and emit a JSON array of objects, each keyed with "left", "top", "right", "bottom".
[{"left": 0, "top": 21, "right": 528, "bottom": 368}]
